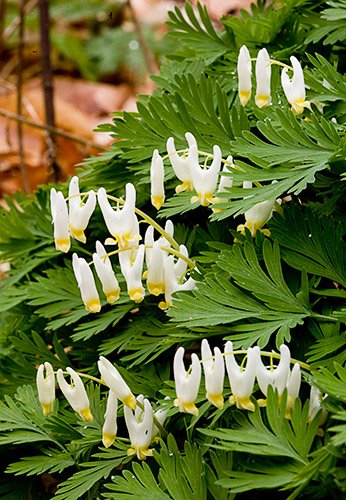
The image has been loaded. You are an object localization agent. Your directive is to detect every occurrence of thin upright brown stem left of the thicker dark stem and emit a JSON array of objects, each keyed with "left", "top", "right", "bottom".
[{"left": 17, "top": 0, "right": 30, "bottom": 194}]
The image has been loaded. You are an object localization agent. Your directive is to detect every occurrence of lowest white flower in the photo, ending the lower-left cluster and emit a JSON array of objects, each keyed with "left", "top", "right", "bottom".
[{"left": 124, "top": 394, "right": 154, "bottom": 460}]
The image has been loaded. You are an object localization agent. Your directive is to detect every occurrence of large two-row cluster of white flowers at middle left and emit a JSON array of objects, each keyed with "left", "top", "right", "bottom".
[{"left": 51, "top": 177, "right": 195, "bottom": 313}]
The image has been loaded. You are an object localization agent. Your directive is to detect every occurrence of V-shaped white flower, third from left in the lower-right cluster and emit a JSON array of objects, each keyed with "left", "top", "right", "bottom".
[{"left": 225, "top": 340, "right": 259, "bottom": 411}]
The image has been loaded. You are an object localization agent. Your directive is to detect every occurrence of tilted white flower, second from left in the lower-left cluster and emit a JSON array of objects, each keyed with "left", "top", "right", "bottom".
[{"left": 57, "top": 367, "right": 93, "bottom": 422}]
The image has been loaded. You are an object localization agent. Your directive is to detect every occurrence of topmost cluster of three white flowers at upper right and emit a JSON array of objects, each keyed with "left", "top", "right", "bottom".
[{"left": 237, "top": 45, "right": 310, "bottom": 115}]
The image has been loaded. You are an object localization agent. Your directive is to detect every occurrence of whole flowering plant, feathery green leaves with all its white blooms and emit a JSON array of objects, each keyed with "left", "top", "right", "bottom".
[{"left": 0, "top": 0, "right": 346, "bottom": 500}]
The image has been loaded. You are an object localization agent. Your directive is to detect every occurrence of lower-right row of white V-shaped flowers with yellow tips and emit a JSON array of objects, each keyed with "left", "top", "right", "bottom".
[{"left": 173, "top": 339, "right": 301, "bottom": 417}]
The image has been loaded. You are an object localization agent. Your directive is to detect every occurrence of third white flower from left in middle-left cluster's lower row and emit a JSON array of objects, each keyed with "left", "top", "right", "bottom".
[{"left": 119, "top": 245, "right": 145, "bottom": 303}]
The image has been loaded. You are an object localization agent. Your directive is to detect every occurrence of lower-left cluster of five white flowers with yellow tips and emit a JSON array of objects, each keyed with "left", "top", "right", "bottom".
[{"left": 36, "top": 356, "right": 168, "bottom": 460}]
